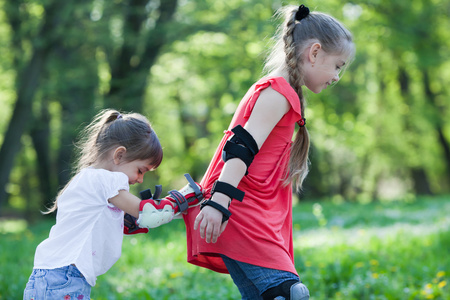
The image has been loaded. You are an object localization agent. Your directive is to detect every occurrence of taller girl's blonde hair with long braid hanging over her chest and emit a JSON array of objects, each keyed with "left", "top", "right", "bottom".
[{"left": 264, "top": 5, "right": 355, "bottom": 191}]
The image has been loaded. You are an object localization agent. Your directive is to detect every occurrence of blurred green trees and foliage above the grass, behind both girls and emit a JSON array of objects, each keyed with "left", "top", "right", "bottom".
[{"left": 0, "top": 0, "right": 450, "bottom": 217}]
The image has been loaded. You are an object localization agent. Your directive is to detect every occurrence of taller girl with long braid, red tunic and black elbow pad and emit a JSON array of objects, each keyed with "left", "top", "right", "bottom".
[{"left": 185, "top": 5, "right": 354, "bottom": 300}]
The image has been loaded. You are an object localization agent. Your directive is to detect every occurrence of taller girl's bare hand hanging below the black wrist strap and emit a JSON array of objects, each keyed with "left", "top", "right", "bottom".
[{"left": 194, "top": 200, "right": 228, "bottom": 243}]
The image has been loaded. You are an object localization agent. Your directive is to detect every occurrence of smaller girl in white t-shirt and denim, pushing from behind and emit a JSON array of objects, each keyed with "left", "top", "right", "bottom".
[{"left": 23, "top": 110, "right": 185, "bottom": 300}]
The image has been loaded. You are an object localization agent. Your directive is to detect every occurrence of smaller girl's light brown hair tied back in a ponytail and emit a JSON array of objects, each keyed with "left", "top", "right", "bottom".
[{"left": 46, "top": 109, "right": 163, "bottom": 213}]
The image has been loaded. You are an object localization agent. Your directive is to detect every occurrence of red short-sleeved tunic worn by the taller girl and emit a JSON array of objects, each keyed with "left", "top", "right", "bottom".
[{"left": 183, "top": 77, "right": 301, "bottom": 274}]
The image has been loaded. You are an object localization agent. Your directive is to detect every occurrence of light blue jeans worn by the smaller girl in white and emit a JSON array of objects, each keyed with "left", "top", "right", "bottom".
[{"left": 23, "top": 265, "right": 91, "bottom": 300}]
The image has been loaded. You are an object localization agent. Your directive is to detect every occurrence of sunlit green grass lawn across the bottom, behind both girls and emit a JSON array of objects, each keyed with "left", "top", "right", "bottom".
[{"left": 0, "top": 197, "right": 450, "bottom": 300}]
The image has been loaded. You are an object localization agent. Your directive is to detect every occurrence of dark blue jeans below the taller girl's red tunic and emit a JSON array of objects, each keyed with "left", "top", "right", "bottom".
[{"left": 221, "top": 255, "right": 300, "bottom": 300}]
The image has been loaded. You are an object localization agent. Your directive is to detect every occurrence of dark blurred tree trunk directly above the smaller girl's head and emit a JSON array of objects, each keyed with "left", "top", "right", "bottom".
[{"left": 103, "top": 0, "right": 178, "bottom": 111}]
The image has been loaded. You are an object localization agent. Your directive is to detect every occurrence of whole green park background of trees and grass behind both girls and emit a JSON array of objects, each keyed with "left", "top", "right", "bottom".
[{"left": 0, "top": 0, "right": 450, "bottom": 299}]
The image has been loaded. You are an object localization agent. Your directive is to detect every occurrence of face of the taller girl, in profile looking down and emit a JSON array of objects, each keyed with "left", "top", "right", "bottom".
[{"left": 303, "top": 43, "right": 348, "bottom": 94}]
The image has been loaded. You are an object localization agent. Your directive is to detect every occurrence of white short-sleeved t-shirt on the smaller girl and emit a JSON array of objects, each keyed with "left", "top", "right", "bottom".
[{"left": 34, "top": 168, "right": 129, "bottom": 286}]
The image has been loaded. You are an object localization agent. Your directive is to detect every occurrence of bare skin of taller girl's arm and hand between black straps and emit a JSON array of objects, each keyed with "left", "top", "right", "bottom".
[{"left": 194, "top": 87, "right": 290, "bottom": 243}]
